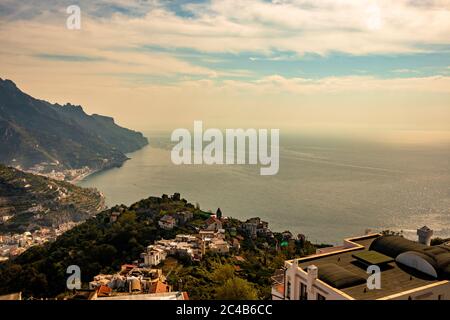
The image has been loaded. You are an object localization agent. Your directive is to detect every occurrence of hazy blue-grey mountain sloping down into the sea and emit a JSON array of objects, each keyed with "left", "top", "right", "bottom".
[{"left": 0, "top": 78, "right": 148, "bottom": 178}]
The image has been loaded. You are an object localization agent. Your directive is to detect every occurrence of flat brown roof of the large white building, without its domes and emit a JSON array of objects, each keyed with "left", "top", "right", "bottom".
[{"left": 298, "top": 235, "right": 448, "bottom": 300}]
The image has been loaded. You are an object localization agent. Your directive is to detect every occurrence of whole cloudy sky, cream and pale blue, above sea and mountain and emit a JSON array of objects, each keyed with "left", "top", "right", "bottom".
[{"left": 0, "top": 0, "right": 450, "bottom": 143}]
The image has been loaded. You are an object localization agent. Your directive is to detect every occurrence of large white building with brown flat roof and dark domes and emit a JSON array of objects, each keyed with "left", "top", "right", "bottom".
[{"left": 272, "top": 228, "right": 450, "bottom": 300}]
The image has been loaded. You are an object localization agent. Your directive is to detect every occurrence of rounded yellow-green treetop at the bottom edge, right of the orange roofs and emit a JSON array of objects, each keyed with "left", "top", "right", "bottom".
[{"left": 216, "top": 277, "right": 258, "bottom": 300}]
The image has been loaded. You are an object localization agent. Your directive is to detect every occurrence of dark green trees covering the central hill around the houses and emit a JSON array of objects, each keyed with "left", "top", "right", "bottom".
[{"left": 0, "top": 194, "right": 315, "bottom": 299}]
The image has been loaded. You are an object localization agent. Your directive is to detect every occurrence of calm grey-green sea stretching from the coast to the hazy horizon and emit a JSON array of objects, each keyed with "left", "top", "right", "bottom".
[{"left": 79, "top": 134, "right": 450, "bottom": 243}]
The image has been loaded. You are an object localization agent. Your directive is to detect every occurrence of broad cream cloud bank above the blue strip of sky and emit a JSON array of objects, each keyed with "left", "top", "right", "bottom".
[{"left": 0, "top": 0, "right": 450, "bottom": 89}]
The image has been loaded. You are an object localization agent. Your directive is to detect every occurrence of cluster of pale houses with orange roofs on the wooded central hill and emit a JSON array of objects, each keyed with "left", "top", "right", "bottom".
[{"left": 61, "top": 194, "right": 316, "bottom": 300}]
